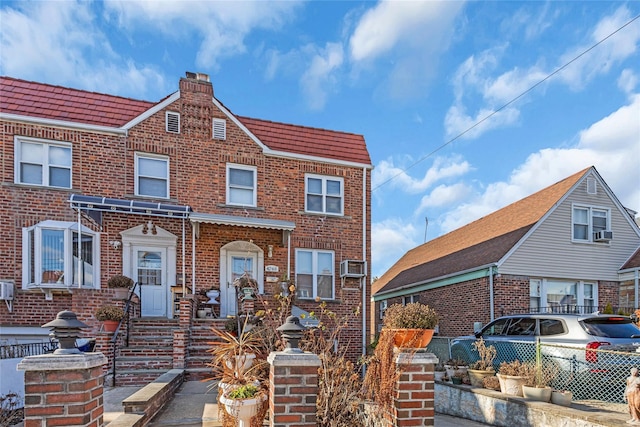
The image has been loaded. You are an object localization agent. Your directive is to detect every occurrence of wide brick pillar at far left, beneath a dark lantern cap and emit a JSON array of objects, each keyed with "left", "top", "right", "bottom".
[{"left": 18, "top": 353, "right": 107, "bottom": 427}]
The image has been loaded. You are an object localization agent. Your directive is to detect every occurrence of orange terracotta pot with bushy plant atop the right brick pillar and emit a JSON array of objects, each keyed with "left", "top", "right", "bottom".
[{"left": 383, "top": 302, "right": 439, "bottom": 348}]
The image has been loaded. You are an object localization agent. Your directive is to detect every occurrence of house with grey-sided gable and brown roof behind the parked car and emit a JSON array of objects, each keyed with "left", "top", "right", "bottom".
[{"left": 373, "top": 167, "right": 640, "bottom": 336}]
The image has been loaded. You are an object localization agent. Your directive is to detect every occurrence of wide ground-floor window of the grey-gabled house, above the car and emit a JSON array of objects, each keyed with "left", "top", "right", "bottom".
[{"left": 529, "top": 279, "right": 598, "bottom": 313}]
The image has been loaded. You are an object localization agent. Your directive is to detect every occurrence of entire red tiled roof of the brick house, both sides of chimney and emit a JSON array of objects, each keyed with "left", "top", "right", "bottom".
[{"left": 0, "top": 77, "right": 371, "bottom": 165}]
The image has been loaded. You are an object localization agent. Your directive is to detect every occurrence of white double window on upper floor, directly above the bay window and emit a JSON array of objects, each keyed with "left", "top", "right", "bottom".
[{"left": 14, "top": 137, "right": 71, "bottom": 188}]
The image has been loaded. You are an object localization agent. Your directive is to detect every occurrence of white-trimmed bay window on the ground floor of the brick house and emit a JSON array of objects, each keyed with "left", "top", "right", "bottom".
[{"left": 22, "top": 220, "right": 100, "bottom": 288}]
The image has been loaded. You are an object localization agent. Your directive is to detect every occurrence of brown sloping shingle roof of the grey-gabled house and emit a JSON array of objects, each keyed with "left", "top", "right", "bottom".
[{"left": 372, "top": 168, "right": 590, "bottom": 294}]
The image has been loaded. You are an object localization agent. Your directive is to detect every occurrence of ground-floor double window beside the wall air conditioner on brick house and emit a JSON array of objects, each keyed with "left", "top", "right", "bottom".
[{"left": 296, "top": 249, "right": 335, "bottom": 299}]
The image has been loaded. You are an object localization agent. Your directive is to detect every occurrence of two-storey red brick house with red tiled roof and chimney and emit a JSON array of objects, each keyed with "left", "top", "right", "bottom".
[{"left": 0, "top": 73, "right": 372, "bottom": 384}]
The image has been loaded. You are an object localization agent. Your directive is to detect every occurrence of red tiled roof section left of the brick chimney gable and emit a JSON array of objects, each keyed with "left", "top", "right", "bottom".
[{"left": 0, "top": 77, "right": 154, "bottom": 128}]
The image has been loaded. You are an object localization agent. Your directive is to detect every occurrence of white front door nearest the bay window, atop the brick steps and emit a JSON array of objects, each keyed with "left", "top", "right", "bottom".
[{"left": 133, "top": 246, "right": 168, "bottom": 317}]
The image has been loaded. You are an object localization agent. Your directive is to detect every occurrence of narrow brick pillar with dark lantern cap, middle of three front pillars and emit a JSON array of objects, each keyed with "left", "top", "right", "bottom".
[{"left": 267, "top": 351, "right": 320, "bottom": 427}]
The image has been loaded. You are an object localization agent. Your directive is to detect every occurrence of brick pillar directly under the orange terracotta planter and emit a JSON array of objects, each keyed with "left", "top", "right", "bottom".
[{"left": 393, "top": 349, "right": 438, "bottom": 427}]
